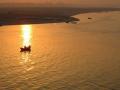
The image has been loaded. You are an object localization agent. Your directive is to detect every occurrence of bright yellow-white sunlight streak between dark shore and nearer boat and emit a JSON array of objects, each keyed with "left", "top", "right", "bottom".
[{"left": 21, "top": 25, "right": 32, "bottom": 46}]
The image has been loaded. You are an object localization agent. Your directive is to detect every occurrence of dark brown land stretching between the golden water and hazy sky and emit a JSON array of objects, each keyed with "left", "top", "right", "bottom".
[{"left": 0, "top": 6, "right": 120, "bottom": 26}]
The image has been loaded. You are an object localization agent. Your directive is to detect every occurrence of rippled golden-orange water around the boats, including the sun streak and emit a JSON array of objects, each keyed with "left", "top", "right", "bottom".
[{"left": 0, "top": 12, "right": 120, "bottom": 90}]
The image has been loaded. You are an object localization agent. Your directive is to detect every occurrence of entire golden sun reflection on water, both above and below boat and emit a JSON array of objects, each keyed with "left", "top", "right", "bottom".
[{"left": 20, "top": 25, "right": 34, "bottom": 72}]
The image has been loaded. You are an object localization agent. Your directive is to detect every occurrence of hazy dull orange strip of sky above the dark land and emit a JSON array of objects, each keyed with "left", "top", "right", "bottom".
[{"left": 0, "top": 0, "right": 120, "bottom": 7}]
